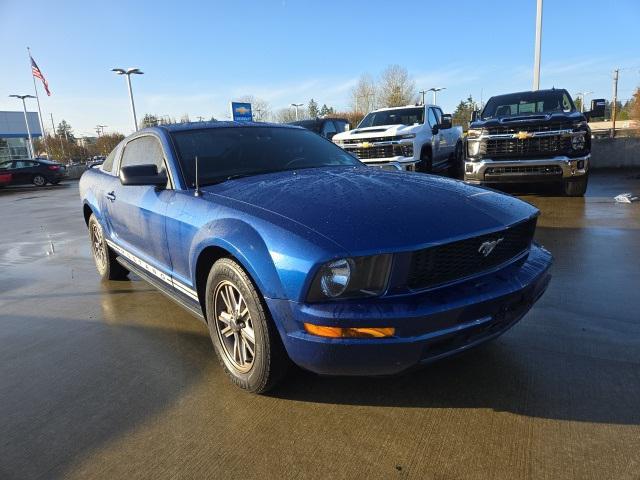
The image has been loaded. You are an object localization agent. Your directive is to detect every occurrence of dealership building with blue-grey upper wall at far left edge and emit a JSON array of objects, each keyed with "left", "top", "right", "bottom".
[{"left": 0, "top": 111, "right": 42, "bottom": 162}]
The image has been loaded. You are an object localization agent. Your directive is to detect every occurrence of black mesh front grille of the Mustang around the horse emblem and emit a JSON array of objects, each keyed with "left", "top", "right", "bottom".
[{"left": 407, "top": 218, "right": 537, "bottom": 290}]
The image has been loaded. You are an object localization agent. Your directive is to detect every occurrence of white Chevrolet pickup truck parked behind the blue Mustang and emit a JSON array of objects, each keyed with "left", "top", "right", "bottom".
[{"left": 333, "top": 105, "right": 463, "bottom": 174}]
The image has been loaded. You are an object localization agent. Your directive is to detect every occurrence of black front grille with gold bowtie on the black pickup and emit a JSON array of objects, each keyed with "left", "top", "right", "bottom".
[{"left": 480, "top": 135, "right": 571, "bottom": 158}]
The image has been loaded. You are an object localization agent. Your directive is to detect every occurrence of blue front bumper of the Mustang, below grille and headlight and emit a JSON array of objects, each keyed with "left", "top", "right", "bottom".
[{"left": 267, "top": 245, "right": 553, "bottom": 375}]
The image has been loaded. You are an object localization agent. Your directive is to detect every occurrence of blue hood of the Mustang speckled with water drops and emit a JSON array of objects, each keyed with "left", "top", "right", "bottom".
[{"left": 203, "top": 167, "right": 537, "bottom": 255}]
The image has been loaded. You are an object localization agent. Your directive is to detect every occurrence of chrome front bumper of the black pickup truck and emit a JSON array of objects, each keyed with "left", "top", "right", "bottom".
[{"left": 464, "top": 154, "right": 591, "bottom": 184}]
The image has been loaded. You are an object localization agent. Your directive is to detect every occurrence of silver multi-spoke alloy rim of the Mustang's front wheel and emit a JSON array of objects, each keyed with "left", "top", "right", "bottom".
[{"left": 214, "top": 280, "right": 256, "bottom": 373}]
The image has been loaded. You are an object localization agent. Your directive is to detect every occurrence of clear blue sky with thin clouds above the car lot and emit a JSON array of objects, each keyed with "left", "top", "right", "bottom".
[{"left": 0, "top": 0, "right": 640, "bottom": 135}]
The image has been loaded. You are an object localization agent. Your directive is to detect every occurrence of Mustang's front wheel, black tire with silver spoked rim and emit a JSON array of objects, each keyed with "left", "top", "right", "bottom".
[{"left": 205, "top": 258, "right": 291, "bottom": 393}]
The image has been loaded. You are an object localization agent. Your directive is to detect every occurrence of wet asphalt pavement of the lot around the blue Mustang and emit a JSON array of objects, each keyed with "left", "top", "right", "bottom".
[{"left": 0, "top": 171, "right": 640, "bottom": 480}]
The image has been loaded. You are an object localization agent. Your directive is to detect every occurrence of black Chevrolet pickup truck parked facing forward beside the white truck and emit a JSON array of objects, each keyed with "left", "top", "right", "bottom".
[{"left": 464, "top": 89, "right": 604, "bottom": 196}]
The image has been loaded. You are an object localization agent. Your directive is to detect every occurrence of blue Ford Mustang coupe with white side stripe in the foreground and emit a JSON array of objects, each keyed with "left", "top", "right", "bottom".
[{"left": 80, "top": 122, "right": 552, "bottom": 392}]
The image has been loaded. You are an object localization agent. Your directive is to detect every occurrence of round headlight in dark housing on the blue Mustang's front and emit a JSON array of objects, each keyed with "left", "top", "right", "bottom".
[{"left": 307, "top": 255, "right": 391, "bottom": 302}]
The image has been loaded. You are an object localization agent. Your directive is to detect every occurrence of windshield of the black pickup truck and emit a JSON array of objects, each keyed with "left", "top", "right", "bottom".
[{"left": 482, "top": 90, "right": 576, "bottom": 119}]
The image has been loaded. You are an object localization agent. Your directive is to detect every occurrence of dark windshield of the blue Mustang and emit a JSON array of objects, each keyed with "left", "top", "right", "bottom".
[{"left": 171, "top": 127, "right": 362, "bottom": 186}]
